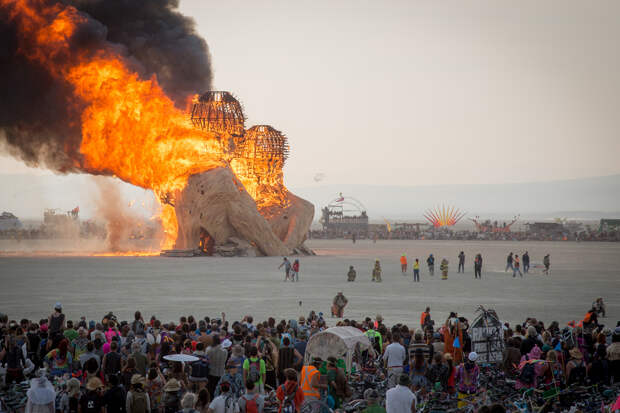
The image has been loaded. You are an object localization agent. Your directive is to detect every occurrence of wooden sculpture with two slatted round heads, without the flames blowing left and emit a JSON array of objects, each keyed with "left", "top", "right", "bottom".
[{"left": 174, "top": 92, "right": 314, "bottom": 255}]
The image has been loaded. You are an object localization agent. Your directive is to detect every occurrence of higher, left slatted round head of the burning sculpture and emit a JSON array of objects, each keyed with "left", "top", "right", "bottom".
[{"left": 191, "top": 91, "right": 245, "bottom": 136}]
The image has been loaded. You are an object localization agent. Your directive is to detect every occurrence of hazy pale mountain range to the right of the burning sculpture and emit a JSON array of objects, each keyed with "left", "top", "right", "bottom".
[{"left": 290, "top": 175, "right": 620, "bottom": 220}]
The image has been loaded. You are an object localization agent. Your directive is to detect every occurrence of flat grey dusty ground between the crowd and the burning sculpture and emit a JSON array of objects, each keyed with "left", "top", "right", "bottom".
[{"left": 0, "top": 240, "right": 620, "bottom": 325}]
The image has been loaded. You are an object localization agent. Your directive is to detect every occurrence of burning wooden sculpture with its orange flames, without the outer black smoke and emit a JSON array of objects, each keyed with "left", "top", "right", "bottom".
[{"left": 0, "top": 0, "right": 314, "bottom": 255}]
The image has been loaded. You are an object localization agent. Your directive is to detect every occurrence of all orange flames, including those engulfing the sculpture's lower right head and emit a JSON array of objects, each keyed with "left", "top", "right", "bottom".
[{"left": 0, "top": 0, "right": 288, "bottom": 248}]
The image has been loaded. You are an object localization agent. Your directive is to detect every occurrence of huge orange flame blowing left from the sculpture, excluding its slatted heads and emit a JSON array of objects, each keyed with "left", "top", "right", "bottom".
[{"left": 0, "top": 0, "right": 224, "bottom": 248}]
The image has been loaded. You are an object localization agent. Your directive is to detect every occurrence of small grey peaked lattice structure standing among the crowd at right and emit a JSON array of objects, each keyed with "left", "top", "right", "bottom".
[{"left": 471, "top": 306, "right": 504, "bottom": 363}]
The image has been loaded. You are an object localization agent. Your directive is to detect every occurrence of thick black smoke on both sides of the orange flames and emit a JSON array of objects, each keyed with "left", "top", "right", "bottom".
[{"left": 0, "top": 0, "right": 212, "bottom": 172}]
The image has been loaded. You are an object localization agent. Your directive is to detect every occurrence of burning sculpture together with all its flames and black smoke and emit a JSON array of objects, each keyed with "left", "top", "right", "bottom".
[{"left": 0, "top": 0, "right": 314, "bottom": 255}]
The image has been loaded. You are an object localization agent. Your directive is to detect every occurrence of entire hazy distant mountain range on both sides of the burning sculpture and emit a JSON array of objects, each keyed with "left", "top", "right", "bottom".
[{"left": 0, "top": 174, "right": 620, "bottom": 221}]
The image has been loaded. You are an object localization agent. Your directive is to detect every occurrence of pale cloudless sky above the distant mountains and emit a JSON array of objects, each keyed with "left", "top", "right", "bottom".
[{"left": 0, "top": 0, "right": 620, "bottom": 187}]
